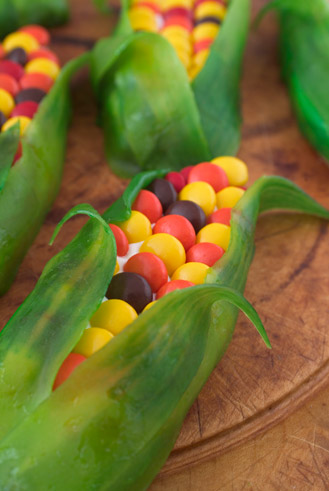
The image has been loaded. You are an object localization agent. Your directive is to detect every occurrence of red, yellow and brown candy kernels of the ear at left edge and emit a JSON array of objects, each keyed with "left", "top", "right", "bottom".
[{"left": 0, "top": 25, "right": 60, "bottom": 160}]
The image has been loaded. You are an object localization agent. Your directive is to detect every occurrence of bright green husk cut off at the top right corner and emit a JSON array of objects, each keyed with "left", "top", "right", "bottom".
[{"left": 266, "top": 0, "right": 329, "bottom": 165}]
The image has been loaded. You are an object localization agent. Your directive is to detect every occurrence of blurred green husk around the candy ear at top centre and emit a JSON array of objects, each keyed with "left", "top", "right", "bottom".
[{"left": 91, "top": 0, "right": 249, "bottom": 177}]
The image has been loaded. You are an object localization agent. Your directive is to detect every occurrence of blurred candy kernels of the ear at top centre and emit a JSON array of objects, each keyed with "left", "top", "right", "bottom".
[{"left": 129, "top": 0, "right": 227, "bottom": 79}]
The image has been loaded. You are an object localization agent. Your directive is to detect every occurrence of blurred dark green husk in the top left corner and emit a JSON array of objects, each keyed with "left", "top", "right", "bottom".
[{"left": 0, "top": 0, "right": 69, "bottom": 37}]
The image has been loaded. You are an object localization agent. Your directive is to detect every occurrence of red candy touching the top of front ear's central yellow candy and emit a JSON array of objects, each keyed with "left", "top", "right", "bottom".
[{"left": 153, "top": 215, "right": 195, "bottom": 251}]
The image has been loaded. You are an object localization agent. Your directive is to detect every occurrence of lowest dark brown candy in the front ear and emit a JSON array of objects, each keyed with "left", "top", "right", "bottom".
[{"left": 106, "top": 273, "right": 153, "bottom": 314}]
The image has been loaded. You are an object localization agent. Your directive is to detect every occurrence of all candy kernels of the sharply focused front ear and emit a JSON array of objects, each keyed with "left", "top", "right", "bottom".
[{"left": 54, "top": 157, "right": 248, "bottom": 388}]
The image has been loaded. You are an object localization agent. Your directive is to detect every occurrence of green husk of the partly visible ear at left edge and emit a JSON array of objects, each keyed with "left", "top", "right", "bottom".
[{"left": 0, "top": 51, "right": 89, "bottom": 295}]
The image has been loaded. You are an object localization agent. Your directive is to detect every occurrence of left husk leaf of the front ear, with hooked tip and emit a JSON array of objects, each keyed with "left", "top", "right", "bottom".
[{"left": 0, "top": 205, "right": 116, "bottom": 439}]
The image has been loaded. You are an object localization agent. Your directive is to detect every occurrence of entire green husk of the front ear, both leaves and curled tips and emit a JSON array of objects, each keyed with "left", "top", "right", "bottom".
[{"left": 0, "top": 171, "right": 329, "bottom": 491}]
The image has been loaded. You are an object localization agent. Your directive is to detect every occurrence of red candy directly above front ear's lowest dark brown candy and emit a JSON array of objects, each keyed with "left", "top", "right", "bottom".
[{"left": 123, "top": 252, "right": 168, "bottom": 292}]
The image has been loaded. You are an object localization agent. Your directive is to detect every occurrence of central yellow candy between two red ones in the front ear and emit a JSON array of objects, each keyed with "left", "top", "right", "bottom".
[{"left": 140, "top": 234, "right": 186, "bottom": 276}]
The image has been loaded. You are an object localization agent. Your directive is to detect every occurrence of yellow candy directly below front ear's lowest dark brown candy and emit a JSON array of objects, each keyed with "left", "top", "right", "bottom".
[{"left": 90, "top": 298, "right": 138, "bottom": 335}]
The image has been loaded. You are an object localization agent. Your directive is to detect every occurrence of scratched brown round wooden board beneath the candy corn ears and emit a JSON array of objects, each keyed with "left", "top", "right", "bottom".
[{"left": 0, "top": 0, "right": 329, "bottom": 491}]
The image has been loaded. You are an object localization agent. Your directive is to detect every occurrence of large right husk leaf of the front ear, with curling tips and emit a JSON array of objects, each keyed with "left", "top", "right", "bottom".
[{"left": 0, "top": 172, "right": 329, "bottom": 491}]
